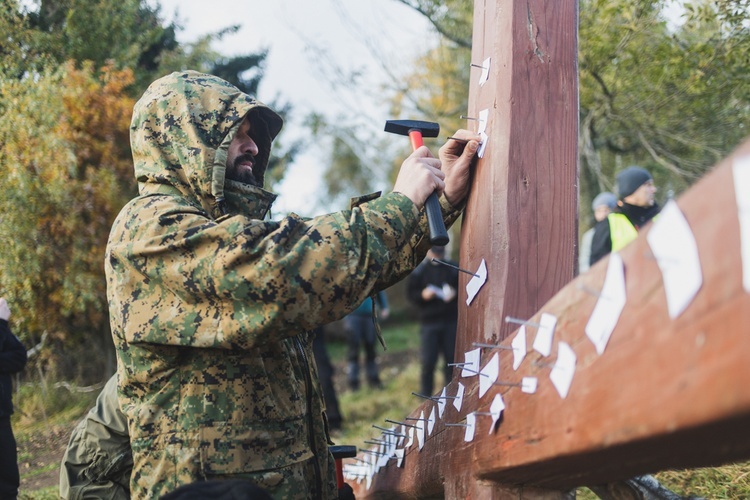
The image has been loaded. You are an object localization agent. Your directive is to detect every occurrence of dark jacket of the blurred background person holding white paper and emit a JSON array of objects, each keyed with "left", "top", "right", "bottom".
[{"left": 406, "top": 260, "right": 458, "bottom": 323}]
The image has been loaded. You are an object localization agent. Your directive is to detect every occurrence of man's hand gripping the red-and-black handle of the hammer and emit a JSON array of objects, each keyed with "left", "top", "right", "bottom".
[{"left": 393, "top": 146, "right": 445, "bottom": 209}]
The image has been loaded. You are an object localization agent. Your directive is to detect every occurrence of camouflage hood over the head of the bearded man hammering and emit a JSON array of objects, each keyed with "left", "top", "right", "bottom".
[{"left": 130, "top": 71, "right": 283, "bottom": 217}]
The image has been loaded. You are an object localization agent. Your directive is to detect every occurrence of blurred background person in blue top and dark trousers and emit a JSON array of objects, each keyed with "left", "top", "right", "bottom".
[{"left": 344, "top": 291, "right": 390, "bottom": 391}]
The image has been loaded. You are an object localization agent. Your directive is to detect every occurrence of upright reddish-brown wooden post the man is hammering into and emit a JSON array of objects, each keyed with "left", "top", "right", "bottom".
[{"left": 457, "top": 0, "right": 578, "bottom": 353}]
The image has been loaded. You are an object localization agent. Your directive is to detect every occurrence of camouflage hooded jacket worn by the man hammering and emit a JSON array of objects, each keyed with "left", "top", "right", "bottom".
[{"left": 105, "top": 72, "right": 458, "bottom": 498}]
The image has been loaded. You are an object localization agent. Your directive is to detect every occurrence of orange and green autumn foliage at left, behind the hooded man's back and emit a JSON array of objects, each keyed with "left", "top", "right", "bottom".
[{"left": 0, "top": 63, "right": 136, "bottom": 378}]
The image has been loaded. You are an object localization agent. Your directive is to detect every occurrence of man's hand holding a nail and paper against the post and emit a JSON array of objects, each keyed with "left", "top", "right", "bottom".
[{"left": 438, "top": 129, "right": 481, "bottom": 207}]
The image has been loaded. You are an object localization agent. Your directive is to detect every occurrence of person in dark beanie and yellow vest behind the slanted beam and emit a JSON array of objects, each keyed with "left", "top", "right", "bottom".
[{"left": 591, "top": 166, "right": 661, "bottom": 266}]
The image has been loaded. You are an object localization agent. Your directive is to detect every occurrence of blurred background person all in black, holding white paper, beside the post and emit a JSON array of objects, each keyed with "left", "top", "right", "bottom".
[{"left": 406, "top": 246, "right": 458, "bottom": 396}]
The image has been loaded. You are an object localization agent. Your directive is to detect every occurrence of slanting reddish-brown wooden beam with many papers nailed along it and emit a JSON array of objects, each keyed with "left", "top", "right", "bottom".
[{"left": 358, "top": 137, "right": 750, "bottom": 498}]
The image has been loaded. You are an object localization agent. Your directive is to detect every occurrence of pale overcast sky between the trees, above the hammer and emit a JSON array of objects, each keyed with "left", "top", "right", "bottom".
[{"left": 150, "top": 0, "right": 434, "bottom": 215}]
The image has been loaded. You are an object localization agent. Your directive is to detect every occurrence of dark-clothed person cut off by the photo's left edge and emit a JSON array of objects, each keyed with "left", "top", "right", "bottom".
[{"left": 0, "top": 298, "right": 26, "bottom": 500}]
